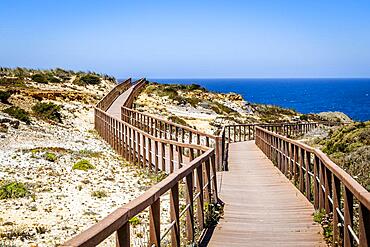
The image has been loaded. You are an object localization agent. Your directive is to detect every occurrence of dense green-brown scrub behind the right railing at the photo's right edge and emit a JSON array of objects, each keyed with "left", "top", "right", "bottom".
[{"left": 320, "top": 121, "right": 370, "bottom": 191}]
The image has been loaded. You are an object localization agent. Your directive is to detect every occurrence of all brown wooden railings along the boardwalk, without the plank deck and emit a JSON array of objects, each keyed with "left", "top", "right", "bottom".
[{"left": 62, "top": 76, "right": 370, "bottom": 247}]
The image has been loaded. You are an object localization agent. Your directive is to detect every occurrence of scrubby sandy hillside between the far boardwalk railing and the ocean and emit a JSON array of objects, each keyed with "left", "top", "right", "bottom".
[{"left": 135, "top": 82, "right": 342, "bottom": 134}]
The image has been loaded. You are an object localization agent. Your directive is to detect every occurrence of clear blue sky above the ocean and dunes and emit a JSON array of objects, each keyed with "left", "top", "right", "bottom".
[{"left": 0, "top": 0, "right": 370, "bottom": 78}]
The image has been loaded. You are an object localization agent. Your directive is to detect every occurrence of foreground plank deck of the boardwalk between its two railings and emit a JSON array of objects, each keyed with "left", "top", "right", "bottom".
[{"left": 209, "top": 141, "right": 326, "bottom": 246}]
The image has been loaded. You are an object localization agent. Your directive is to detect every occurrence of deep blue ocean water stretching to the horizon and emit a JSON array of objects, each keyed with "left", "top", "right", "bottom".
[{"left": 149, "top": 79, "right": 370, "bottom": 121}]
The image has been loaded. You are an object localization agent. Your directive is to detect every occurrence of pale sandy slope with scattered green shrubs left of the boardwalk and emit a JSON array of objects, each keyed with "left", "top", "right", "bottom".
[{"left": 0, "top": 68, "right": 150, "bottom": 246}]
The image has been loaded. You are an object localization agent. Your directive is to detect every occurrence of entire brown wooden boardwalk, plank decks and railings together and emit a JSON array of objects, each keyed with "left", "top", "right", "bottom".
[{"left": 62, "top": 79, "right": 370, "bottom": 246}]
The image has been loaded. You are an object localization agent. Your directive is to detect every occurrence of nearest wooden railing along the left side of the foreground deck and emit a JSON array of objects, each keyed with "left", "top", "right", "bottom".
[{"left": 62, "top": 149, "right": 218, "bottom": 247}]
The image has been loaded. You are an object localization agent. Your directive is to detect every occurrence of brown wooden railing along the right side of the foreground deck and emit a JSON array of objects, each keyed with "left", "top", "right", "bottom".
[{"left": 256, "top": 127, "right": 370, "bottom": 246}]
